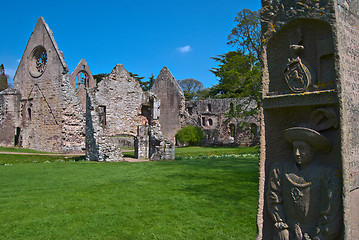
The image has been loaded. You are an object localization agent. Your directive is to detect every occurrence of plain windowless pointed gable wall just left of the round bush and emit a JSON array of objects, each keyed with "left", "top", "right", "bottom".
[{"left": 150, "top": 67, "right": 185, "bottom": 143}]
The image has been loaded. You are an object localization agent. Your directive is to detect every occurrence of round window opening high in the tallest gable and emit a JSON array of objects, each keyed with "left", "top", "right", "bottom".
[{"left": 29, "top": 46, "right": 47, "bottom": 77}]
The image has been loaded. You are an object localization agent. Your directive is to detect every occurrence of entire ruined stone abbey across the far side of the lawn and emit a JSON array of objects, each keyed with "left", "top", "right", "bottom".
[{"left": 0, "top": 17, "right": 258, "bottom": 161}]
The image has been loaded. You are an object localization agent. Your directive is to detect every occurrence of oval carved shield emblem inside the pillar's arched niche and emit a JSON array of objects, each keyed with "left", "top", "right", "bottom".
[{"left": 284, "top": 57, "right": 311, "bottom": 93}]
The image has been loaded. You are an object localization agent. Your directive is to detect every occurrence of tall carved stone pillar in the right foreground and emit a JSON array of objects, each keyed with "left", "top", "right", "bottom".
[{"left": 257, "top": 0, "right": 359, "bottom": 240}]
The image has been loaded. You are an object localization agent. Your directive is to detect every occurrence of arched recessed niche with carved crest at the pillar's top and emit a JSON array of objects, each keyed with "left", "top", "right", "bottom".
[{"left": 267, "top": 19, "right": 335, "bottom": 95}]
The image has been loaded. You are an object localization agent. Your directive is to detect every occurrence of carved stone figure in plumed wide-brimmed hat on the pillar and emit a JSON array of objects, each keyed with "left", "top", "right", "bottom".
[{"left": 266, "top": 107, "right": 342, "bottom": 240}]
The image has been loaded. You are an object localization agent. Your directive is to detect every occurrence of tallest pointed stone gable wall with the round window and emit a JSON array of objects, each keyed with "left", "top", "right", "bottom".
[{"left": 12, "top": 17, "right": 84, "bottom": 152}]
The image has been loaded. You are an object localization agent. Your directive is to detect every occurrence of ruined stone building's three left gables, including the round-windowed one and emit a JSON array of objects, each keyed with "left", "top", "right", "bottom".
[{"left": 0, "top": 17, "right": 174, "bottom": 161}]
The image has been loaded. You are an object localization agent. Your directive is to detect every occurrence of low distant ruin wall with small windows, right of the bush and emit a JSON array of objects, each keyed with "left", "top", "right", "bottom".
[{"left": 182, "top": 99, "right": 259, "bottom": 146}]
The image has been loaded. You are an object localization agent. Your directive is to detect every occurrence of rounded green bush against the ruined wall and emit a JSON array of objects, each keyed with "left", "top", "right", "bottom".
[{"left": 176, "top": 125, "right": 204, "bottom": 146}]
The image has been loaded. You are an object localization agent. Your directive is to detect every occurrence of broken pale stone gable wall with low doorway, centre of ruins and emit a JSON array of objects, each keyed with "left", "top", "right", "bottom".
[{"left": 86, "top": 64, "right": 174, "bottom": 161}]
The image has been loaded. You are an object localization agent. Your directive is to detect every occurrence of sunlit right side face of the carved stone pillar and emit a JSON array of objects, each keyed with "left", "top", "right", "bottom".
[{"left": 335, "top": 0, "right": 359, "bottom": 239}]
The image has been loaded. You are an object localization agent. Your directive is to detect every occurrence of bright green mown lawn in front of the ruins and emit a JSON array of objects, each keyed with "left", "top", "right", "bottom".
[{"left": 0, "top": 149, "right": 258, "bottom": 240}]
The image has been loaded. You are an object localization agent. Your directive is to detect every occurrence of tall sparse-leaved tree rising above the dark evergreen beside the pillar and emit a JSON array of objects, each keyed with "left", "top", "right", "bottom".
[{"left": 227, "top": 9, "right": 261, "bottom": 66}]
